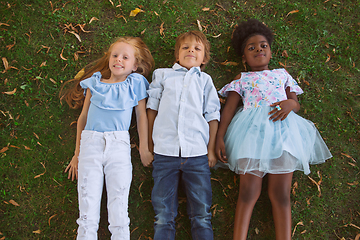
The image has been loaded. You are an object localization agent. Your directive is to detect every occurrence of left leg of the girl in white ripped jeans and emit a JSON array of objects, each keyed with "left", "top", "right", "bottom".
[{"left": 76, "top": 132, "right": 104, "bottom": 240}]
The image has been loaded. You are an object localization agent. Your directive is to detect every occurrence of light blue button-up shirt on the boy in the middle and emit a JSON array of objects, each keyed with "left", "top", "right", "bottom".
[{"left": 147, "top": 63, "right": 220, "bottom": 157}]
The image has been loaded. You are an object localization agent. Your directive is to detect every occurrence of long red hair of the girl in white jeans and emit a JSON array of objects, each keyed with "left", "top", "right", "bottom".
[{"left": 60, "top": 36, "right": 155, "bottom": 109}]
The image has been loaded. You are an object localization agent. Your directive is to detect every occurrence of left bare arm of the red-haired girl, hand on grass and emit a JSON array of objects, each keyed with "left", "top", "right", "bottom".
[{"left": 65, "top": 88, "right": 91, "bottom": 181}]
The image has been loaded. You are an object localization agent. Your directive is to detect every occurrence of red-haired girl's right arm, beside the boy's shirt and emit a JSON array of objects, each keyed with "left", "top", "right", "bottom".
[{"left": 135, "top": 98, "right": 154, "bottom": 167}]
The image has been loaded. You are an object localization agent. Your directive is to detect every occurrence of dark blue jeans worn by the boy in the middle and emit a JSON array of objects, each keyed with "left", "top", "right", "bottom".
[{"left": 151, "top": 154, "right": 213, "bottom": 240}]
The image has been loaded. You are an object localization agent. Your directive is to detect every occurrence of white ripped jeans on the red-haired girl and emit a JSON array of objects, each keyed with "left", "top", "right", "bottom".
[{"left": 76, "top": 130, "right": 132, "bottom": 240}]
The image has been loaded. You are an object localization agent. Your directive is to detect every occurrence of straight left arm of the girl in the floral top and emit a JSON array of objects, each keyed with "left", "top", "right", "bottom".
[{"left": 215, "top": 91, "right": 241, "bottom": 163}]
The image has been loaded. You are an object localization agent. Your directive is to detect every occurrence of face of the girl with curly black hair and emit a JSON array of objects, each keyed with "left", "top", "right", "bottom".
[{"left": 242, "top": 35, "right": 271, "bottom": 72}]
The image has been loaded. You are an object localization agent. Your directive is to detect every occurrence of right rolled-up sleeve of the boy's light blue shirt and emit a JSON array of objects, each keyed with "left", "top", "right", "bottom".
[{"left": 203, "top": 76, "right": 220, "bottom": 122}]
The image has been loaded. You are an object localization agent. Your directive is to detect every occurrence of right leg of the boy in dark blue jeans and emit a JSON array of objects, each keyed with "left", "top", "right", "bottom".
[{"left": 181, "top": 155, "right": 214, "bottom": 240}]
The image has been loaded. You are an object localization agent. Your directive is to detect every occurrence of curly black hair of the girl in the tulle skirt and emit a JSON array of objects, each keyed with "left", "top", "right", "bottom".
[{"left": 231, "top": 19, "right": 274, "bottom": 56}]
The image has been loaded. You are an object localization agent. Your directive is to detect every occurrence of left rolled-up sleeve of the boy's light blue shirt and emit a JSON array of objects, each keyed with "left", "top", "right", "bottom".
[{"left": 146, "top": 69, "right": 164, "bottom": 111}]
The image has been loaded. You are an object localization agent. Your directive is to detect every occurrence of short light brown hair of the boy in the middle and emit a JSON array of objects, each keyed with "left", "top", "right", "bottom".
[{"left": 174, "top": 31, "right": 210, "bottom": 70}]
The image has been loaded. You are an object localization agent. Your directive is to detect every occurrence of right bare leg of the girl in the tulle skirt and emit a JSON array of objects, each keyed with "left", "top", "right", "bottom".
[{"left": 268, "top": 173, "right": 293, "bottom": 240}]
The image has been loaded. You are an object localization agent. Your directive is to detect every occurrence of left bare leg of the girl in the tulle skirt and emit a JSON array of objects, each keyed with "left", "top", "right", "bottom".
[{"left": 233, "top": 173, "right": 262, "bottom": 240}]
